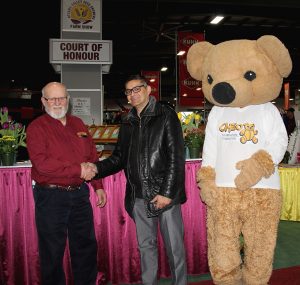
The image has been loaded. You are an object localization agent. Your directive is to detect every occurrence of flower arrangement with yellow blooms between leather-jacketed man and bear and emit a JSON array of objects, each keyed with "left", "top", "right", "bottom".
[{"left": 178, "top": 112, "right": 205, "bottom": 148}]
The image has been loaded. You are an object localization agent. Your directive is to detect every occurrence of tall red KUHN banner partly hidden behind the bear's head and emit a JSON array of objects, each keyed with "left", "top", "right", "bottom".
[{"left": 177, "top": 32, "right": 204, "bottom": 107}]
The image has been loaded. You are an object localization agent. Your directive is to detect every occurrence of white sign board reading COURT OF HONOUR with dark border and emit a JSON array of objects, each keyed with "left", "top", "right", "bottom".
[{"left": 49, "top": 39, "right": 112, "bottom": 64}]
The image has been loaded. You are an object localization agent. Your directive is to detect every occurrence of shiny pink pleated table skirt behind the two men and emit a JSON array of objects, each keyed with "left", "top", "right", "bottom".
[{"left": 0, "top": 161, "right": 208, "bottom": 285}]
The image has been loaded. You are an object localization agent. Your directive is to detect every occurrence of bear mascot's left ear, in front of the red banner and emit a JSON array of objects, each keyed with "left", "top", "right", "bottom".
[{"left": 186, "top": 42, "right": 213, "bottom": 80}]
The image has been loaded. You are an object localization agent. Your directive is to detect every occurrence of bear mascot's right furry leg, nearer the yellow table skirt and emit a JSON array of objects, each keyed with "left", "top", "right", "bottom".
[{"left": 242, "top": 189, "right": 282, "bottom": 285}]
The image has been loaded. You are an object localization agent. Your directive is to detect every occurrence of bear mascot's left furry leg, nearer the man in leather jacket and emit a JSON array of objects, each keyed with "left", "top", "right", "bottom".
[{"left": 207, "top": 188, "right": 242, "bottom": 285}]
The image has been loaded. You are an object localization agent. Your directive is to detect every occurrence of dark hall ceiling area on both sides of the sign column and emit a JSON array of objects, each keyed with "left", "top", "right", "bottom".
[{"left": 0, "top": 0, "right": 300, "bottom": 107}]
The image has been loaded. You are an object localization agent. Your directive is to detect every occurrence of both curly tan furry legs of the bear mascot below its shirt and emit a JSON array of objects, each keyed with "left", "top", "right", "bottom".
[{"left": 207, "top": 188, "right": 282, "bottom": 285}]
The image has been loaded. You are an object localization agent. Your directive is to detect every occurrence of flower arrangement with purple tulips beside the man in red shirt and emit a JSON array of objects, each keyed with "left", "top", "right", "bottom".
[{"left": 0, "top": 107, "right": 26, "bottom": 154}]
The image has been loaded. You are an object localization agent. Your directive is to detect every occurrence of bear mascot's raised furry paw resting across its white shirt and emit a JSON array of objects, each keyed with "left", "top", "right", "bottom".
[{"left": 234, "top": 150, "right": 275, "bottom": 190}]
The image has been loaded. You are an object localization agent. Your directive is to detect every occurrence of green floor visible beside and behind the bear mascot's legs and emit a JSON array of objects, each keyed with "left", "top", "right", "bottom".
[{"left": 159, "top": 221, "right": 300, "bottom": 285}]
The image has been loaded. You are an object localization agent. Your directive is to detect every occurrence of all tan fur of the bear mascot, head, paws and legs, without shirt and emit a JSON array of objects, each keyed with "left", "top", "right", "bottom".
[{"left": 187, "top": 35, "right": 292, "bottom": 285}]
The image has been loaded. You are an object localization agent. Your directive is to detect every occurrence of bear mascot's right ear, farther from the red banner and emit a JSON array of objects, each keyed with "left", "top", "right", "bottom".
[{"left": 257, "top": 35, "right": 292, "bottom": 77}]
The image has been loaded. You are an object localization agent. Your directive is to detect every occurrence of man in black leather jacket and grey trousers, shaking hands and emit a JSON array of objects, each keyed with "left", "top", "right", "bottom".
[{"left": 96, "top": 75, "right": 187, "bottom": 285}]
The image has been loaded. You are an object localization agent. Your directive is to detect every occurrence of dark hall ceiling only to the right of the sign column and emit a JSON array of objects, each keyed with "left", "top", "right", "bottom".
[{"left": 102, "top": 0, "right": 300, "bottom": 103}]
